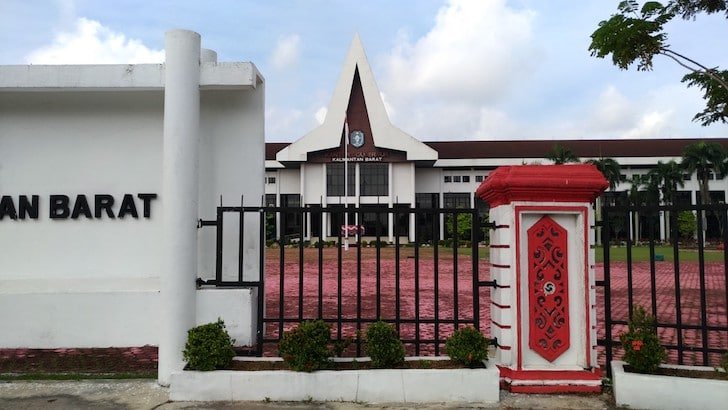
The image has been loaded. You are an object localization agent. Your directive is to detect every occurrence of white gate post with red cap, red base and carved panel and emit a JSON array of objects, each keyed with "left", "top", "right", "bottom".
[{"left": 476, "top": 164, "right": 608, "bottom": 393}]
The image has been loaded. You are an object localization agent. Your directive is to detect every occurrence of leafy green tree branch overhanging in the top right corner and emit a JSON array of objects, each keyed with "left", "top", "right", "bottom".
[{"left": 589, "top": 0, "right": 728, "bottom": 125}]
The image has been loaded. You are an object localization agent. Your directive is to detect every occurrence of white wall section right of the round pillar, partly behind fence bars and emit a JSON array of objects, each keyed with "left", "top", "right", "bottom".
[{"left": 198, "top": 87, "right": 265, "bottom": 280}]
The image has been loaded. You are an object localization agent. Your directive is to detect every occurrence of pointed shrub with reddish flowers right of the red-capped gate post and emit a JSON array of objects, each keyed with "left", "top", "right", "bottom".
[{"left": 619, "top": 305, "right": 667, "bottom": 373}]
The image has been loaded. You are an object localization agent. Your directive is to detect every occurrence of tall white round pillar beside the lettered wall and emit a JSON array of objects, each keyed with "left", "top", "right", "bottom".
[{"left": 158, "top": 30, "right": 200, "bottom": 385}]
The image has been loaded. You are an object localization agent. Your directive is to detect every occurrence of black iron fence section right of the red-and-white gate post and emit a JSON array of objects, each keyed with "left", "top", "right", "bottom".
[{"left": 596, "top": 204, "right": 728, "bottom": 374}]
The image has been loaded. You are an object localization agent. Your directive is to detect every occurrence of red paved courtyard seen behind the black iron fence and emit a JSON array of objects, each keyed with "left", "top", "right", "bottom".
[{"left": 265, "top": 248, "right": 728, "bottom": 364}]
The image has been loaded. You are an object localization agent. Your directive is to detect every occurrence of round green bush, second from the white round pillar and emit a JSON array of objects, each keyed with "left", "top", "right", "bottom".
[{"left": 278, "top": 320, "right": 332, "bottom": 372}]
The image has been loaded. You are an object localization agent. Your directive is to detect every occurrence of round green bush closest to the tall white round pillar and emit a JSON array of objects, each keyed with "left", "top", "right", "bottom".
[{"left": 182, "top": 319, "right": 235, "bottom": 371}]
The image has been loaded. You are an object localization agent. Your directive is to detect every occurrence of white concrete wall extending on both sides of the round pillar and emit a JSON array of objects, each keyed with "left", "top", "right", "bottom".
[{"left": 0, "top": 75, "right": 264, "bottom": 348}]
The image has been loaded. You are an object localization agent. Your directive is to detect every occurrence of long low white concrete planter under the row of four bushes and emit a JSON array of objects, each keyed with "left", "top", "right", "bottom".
[{"left": 170, "top": 358, "right": 500, "bottom": 403}]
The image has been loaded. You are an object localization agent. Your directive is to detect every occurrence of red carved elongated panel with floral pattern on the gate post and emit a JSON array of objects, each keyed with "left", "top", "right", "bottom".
[{"left": 528, "top": 216, "right": 570, "bottom": 362}]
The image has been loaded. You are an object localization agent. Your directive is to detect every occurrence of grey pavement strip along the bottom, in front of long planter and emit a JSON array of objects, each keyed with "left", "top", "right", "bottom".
[{"left": 0, "top": 380, "right": 614, "bottom": 410}]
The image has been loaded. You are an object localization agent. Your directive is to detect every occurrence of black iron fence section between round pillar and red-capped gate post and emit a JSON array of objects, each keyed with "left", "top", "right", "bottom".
[{"left": 199, "top": 206, "right": 494, "bottom": 356}]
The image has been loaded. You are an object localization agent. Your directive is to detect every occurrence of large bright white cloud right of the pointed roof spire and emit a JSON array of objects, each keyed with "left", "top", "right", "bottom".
[{"left": 382, "top": 0, "right": 537, "bottom": 139}]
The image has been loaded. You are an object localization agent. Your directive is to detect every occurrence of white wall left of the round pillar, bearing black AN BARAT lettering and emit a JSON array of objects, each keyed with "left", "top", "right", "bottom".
[{"left": 0, "top": 91, "right": 162, "bottom": 347}]
